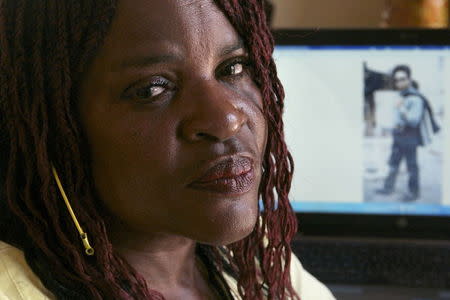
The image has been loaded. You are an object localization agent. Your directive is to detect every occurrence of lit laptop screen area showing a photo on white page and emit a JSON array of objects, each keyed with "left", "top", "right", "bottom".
[{"left": 274, "top": 45, "right": 450, "bottom": 216}]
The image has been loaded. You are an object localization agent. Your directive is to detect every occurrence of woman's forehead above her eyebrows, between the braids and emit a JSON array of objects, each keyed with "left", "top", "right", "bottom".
[{"left": 100, "top": 0, "right": 243, "bottom": 62}]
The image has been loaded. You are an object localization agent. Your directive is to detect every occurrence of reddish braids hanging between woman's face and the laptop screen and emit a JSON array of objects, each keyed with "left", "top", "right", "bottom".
[{"left": 216, "top": 0, "right": 298, "bottom": 299}]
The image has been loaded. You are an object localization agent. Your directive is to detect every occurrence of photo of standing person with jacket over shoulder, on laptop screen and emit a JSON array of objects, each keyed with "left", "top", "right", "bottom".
[{"left": 361, "top": 56, "right": 446, "bottom": 204}]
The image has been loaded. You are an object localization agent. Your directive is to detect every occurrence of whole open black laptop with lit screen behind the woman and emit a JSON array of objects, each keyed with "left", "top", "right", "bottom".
[{"left": 274, "top": 29, "right": 450, "bottom": 299}]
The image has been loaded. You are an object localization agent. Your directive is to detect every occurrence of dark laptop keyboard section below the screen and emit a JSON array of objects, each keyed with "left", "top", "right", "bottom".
[{"left": 293, "top": 237, "right": 450, "bottom": 289}]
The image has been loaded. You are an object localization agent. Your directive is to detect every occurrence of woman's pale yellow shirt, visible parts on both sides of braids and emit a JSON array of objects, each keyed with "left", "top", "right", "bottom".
[{"left": 0, "top": 241, "right": 336, "bottom": 300}]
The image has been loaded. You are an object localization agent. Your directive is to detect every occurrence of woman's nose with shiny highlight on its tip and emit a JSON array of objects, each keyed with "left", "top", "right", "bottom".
[{"left": 181, "top": 82, "right": 248, "bottom": 142}]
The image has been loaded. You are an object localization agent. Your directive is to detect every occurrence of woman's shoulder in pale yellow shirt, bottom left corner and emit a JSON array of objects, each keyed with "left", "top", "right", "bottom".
[{"left": 0, "top": 241, "right": 53, "bottom": 300}]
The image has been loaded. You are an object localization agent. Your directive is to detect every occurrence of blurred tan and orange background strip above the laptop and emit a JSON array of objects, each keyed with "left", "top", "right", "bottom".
[{"left": 272, "top": 0, "right": 449, "bottom": 29}]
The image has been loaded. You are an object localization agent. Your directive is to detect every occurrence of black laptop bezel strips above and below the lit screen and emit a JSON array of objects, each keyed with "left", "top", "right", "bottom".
[{"left": 273, "top": 29, "right": 450, "bottom": 239}]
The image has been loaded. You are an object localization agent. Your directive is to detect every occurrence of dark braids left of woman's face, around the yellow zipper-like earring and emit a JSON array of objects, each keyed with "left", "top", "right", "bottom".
[{"left": 0, "top": 0, "right": 155, "bottom": 299}]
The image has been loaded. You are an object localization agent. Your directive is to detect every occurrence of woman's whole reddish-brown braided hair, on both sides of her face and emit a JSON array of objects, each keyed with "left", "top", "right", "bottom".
[{"left": 0, "top": 0, "right": 298, "bottom": 299}]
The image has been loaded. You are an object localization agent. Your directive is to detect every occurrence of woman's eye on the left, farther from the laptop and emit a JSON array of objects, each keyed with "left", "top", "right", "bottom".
[{"left": 123, "top": 78, "right": 172, "bottom": 100}]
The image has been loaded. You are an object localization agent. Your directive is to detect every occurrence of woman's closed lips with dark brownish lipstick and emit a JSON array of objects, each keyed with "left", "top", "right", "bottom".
[{"left": 188, "top": 156, "right": 255, "bottom": 194}]
